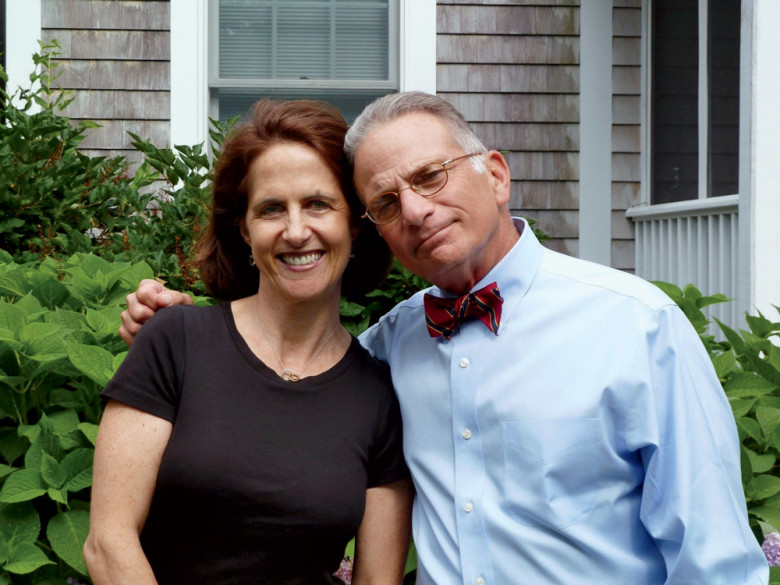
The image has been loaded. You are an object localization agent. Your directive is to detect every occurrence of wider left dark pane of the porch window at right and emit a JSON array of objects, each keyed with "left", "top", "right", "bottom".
[{"left": 651, "top": 0, "right": 699, "bottom": 204}]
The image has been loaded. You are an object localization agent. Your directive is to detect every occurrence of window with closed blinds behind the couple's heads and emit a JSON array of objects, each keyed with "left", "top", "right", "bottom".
[{"left": 209, "top": 0, "right": 399, "bottom": 121}]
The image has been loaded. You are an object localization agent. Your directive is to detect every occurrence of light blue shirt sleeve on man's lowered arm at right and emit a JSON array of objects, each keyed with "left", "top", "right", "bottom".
[{"left": 640, "top": 307, "right": 768, "bottom": 585}]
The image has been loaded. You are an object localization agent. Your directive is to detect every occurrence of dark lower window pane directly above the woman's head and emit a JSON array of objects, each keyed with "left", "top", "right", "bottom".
[{"left": 217, "top": 88, "right": 387, "bottom": 124}]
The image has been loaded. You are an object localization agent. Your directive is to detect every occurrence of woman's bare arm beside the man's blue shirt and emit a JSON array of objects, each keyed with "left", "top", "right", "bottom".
[{"left": 352, "top": 479, "right": 414, "bottom": 585}]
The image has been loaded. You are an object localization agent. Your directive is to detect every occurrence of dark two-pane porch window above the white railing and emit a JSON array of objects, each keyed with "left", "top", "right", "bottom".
[{"left": 650, "top": 0, "right": 741, "bottom": 204}]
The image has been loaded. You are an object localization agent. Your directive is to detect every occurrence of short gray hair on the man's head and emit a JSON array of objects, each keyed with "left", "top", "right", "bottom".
[{"left": 344, "top": 91, "right": 487, "bottom": 164}]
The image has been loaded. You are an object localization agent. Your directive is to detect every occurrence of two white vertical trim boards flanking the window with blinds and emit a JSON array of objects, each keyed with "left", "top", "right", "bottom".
[{"left": 171, "top": 0, "right": 436, "bottom": 144}]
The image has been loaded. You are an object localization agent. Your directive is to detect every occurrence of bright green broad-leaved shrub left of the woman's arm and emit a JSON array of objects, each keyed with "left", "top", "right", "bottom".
[{"left": 0, "top": 252, "right": 152, "bottom": 585}]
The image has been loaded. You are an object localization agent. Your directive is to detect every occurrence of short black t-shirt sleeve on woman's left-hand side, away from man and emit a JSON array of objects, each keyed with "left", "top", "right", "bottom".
[{"left": 101, "top": 307, "right": 188, "bottom": 422}]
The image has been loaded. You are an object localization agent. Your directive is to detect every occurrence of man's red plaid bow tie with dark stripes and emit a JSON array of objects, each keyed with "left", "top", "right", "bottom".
[{"left": 425, "top": 282, "right": 504, "bottom": 339}]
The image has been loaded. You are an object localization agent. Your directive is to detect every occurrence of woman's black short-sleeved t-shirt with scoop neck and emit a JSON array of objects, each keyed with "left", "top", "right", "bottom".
[{"left": 103, "top": 304, "right": 408, "bottom": 585}]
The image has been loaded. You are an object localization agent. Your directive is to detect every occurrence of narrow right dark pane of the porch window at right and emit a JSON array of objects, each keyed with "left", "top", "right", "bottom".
[{"left": 708, "top": 0, "right": 740, "bottom": 197}]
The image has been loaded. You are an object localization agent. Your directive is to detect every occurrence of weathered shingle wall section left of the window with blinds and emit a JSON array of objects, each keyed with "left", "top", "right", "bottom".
[{"left": 41, "top": 0, "right": 170, "bottom": 162}]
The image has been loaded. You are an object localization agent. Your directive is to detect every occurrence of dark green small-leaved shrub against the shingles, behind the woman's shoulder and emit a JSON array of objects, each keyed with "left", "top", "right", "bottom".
[{"left": 0, "top": 41, "right": 235, "bottom": 293}]
